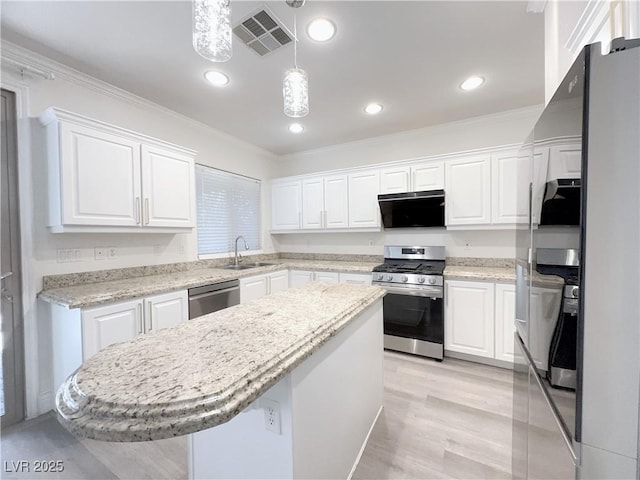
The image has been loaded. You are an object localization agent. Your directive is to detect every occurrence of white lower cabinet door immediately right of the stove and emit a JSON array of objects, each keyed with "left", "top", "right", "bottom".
[{"left": 444, "top": 280, "right": 494, "bottom": 358}]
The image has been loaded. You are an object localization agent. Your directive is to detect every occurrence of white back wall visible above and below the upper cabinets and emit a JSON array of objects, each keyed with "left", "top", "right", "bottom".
[{"left": 273, "top": 107, "right": 541, "bottom": 258}]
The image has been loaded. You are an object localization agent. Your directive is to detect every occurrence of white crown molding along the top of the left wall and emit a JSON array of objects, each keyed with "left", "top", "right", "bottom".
[{"left": 0, "top": 40, "right": 278, "bottom": 159}]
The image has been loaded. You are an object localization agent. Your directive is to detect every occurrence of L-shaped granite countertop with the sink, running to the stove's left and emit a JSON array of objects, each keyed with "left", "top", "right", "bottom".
[{"left": 38, "top": 259, "right": 378, "bottom": 308}]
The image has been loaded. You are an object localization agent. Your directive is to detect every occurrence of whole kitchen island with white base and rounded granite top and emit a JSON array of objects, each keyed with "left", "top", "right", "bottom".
[{"left": 56, "top": 283, "right": 384, "bottom": 478}]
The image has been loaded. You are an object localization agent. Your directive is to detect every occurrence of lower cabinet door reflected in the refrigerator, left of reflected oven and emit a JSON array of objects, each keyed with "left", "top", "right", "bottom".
[{"left": 529, "top": 287, "right": 562, "bottom": 371}]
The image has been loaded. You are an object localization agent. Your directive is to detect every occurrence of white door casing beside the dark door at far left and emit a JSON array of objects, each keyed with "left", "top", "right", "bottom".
[{"left": 1, "top": 77, "right": 40, "bottom": 418}]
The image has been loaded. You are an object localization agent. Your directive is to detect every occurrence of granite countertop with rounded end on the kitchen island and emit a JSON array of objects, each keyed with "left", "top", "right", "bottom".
[{"left": 56, "top": 282, "right": 385, "bottom": 441}]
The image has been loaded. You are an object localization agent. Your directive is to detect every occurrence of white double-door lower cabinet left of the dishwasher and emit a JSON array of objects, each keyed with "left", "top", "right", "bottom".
[{"left": 82, "top": 290, "right": 189, "bottom": 361}]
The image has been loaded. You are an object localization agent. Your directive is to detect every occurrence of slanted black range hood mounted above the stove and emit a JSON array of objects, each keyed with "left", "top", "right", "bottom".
[{"left": 378, "top": 190, "right": 444, "bottom": 228}]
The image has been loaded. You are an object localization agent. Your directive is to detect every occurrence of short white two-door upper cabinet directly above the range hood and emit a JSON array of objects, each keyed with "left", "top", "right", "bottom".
[{"left": 380, "top": 161, "right": 444, "bottom": 193}]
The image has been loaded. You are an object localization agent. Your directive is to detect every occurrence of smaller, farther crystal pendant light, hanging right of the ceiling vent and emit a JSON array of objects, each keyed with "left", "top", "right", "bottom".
[{"left": 282, "top": 0, "right": 309, "bottom": 118}]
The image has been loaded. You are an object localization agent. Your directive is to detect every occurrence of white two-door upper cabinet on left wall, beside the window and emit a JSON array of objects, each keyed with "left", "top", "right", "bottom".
[{"left": 40, "top": 108, "right": 195, "bottom": 233}]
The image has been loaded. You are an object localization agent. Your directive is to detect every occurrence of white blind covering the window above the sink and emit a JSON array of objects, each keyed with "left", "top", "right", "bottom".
[{"left": 196, "top": 165, "right": 261, "bottom": 255}]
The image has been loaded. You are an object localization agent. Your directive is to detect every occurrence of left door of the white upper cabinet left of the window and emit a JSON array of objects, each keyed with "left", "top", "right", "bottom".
[{"left": 58, "top": 122, "right": 141, "bottom": 227}]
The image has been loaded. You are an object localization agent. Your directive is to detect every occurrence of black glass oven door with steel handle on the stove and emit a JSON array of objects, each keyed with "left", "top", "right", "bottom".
[{"left": 383, "top": 286, "right": 444, "bottom": 344}]
